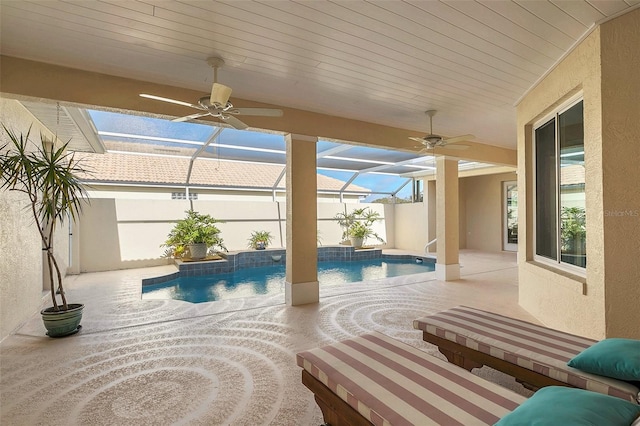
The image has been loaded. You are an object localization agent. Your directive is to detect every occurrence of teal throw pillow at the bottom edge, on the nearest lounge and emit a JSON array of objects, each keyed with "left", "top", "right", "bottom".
[{"left": 495, "top": 386, "right": 640, "bottom": 426}]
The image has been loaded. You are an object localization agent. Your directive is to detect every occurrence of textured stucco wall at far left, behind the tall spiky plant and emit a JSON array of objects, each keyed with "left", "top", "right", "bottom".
[{"left": 0, "top": 98, "right": 68, "bottom": 339}]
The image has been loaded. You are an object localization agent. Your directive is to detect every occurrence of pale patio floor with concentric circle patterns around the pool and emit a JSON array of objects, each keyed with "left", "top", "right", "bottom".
[{"left": 0, "top": 251, "right": 538, "bottom": 426}]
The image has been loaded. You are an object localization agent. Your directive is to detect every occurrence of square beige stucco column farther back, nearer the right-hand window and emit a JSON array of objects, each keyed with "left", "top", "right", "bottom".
[{"left": 436, "top": 156, "right": 460, "bottom": 281}]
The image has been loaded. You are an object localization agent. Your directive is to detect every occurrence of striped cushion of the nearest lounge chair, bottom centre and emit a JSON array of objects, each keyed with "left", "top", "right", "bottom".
[{"left": 297, "top": 332, "right": 525, "bottom": 425}]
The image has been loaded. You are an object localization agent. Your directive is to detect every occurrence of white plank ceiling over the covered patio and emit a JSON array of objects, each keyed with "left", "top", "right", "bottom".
[{"left": 0, "top": 0, "right": 640, "bottom": 148}]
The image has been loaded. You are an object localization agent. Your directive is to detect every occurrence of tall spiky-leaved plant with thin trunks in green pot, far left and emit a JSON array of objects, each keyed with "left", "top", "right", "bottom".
[{"left": 0, "top": 124, "right": 88, "bottom": 337}]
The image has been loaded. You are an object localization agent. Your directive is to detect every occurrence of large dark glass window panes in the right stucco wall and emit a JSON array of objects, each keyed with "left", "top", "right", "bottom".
[{"left": 534, "top": 100, "right": 587, "bottom": 268}]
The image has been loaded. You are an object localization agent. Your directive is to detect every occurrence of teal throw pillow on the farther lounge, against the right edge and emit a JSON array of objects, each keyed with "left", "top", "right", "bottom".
[{"left": 567, "top": 339, "right": 640, "bottom": 381}]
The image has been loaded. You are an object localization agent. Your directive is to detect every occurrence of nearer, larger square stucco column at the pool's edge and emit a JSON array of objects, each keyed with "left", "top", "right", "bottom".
[{"left": 285, "top": 134, "right": 320, "bottom": 306}]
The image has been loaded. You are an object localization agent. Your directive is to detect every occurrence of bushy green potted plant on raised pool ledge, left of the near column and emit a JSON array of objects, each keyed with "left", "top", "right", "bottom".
[{"left": 162, "top": 210, "right": 227, "bottom": 260}]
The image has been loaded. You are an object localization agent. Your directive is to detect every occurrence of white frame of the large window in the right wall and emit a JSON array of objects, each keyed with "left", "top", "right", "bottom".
[{"left": 531, "top": 92, "right": 587, "bottom": 277}]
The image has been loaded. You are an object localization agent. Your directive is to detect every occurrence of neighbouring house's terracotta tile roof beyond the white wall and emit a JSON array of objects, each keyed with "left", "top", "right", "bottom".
[{"left": 76, "top": 152, "right": 371, "bottom": 192}]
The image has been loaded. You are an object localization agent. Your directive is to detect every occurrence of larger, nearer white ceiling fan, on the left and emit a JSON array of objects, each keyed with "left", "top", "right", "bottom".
[{"left": 140, "top": 57, "right": 282, "bottom": 130}]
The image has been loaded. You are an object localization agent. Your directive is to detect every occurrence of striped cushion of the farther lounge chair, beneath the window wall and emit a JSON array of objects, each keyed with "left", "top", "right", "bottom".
[{"left": 413, "top": 306, "right": 640, "bottom": 402}]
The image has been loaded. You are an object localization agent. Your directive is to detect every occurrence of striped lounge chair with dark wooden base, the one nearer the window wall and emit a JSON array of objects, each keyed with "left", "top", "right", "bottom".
[{"left": 413, "top": 306, "right": 640, "bottom": 403}]
